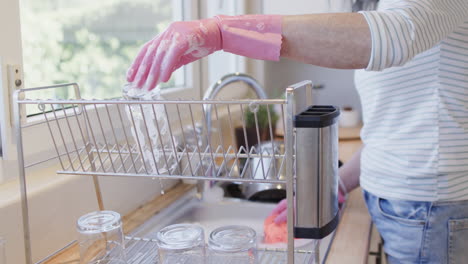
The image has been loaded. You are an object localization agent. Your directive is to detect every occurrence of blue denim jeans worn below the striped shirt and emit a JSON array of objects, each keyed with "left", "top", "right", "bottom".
[{"left": 364, "top": 191, "right": 468, "bottom": 264}]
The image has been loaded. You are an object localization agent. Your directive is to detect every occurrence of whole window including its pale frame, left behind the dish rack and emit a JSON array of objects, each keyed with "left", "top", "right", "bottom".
[{"left": 0, "top": 0, "right": 201, "bottom": 183}]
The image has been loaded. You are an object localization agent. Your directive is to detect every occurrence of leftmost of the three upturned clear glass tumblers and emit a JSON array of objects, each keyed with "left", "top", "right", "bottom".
[{"left": 76, "top": 211, "right": 127, "bottom": 264}]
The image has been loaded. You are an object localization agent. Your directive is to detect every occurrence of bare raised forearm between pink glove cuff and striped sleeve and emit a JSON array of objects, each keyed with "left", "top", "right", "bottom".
[{"left": 281, "top": 13, "right": 372, "bottom": 69}]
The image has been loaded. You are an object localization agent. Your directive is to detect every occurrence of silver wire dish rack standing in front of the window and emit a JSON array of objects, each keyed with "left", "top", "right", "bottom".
[{"left": 13, "top": 81, "right": 319, "bottom": 264}]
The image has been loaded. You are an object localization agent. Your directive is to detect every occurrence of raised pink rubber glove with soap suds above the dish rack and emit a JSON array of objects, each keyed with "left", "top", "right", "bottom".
[{"left": 127, "top": 15, "right": 282, "bottom": 90}]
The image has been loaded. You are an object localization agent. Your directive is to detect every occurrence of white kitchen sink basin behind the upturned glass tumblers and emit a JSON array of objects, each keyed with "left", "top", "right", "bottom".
[{"left": 127, "top": 191, "right": 333, "bottom": 264}]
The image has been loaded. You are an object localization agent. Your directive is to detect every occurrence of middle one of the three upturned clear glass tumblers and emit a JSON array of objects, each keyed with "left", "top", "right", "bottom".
[{"left": 157, "top": 224, "right": 205, "bottom": 264}]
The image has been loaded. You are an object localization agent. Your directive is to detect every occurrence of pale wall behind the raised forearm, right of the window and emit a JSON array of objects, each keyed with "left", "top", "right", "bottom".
[{"left": 263, "top": 0, "right": 361, "bottom": 111}]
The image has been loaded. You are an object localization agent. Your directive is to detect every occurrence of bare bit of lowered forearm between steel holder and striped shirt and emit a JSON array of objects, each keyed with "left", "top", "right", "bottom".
[{"left": 339, "top": 145, "right": 362, "bottom": 192}]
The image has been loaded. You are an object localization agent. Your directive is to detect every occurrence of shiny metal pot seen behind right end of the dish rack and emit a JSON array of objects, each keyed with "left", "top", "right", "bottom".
[{"left": 241, "top": 141, "right": 286, "bottom": 202}]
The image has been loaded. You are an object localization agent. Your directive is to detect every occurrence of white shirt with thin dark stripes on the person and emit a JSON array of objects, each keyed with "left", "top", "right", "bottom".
[{"left": 356, "top": 0, "right": 468, "bottom": 201}]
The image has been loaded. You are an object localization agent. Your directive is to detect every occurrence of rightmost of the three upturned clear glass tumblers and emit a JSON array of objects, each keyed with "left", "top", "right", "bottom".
[{"left": 207, "top": 225, "right": 257, "bottom": 264}]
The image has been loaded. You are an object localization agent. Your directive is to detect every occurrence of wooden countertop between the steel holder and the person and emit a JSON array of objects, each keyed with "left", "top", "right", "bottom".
[{"left": 326, "top": 140, "right": 372, "bottom": 264}]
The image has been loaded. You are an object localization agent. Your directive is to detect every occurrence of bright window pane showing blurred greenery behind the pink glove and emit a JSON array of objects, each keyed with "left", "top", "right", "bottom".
[{"left": 20, "top": 0, "right": 196, "bottom": 107}]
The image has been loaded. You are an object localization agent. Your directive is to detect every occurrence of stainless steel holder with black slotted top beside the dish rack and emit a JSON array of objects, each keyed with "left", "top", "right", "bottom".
[{"left": 294, "top": 106, "right": 340, "bottom": 239}]
